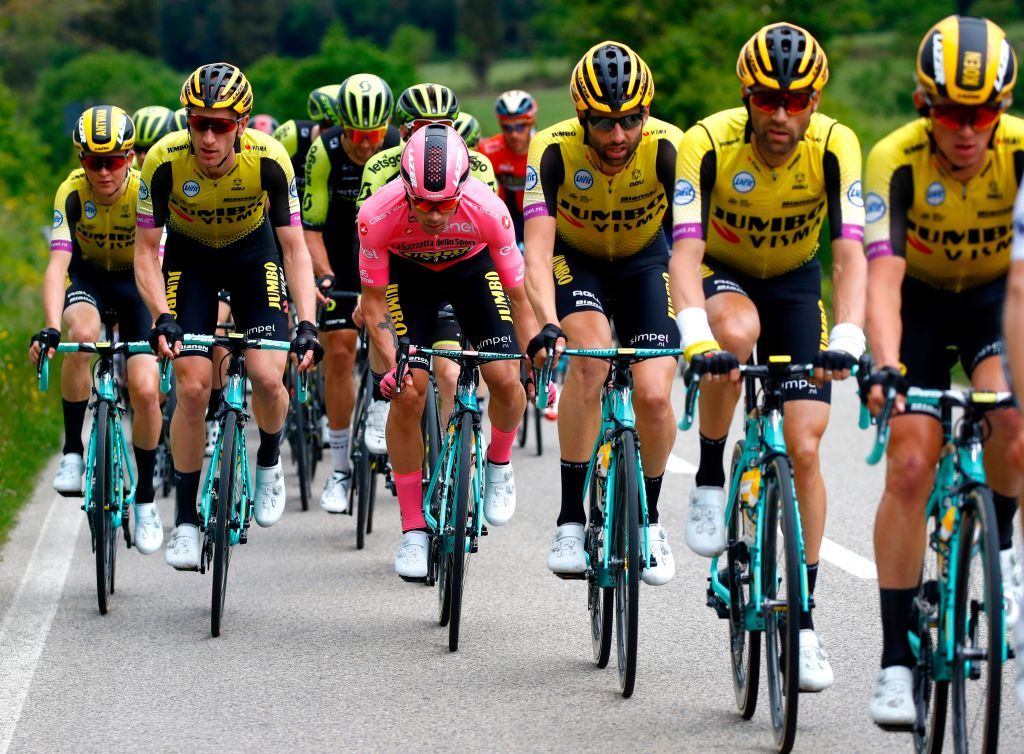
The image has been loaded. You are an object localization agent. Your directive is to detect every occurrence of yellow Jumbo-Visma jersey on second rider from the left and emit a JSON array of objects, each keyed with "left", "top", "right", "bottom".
[{"left": 138, "top": 128, "right": 300, "bottom": 249}]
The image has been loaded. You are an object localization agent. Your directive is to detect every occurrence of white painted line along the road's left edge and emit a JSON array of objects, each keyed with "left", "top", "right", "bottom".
[{"left": 0, "top": 497, "right": 84, "bottom": 754}]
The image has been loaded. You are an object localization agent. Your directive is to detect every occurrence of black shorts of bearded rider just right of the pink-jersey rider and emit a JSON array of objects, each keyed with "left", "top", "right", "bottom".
[{"left": 552, "top": 233, "right": 679, "bottom": 348}]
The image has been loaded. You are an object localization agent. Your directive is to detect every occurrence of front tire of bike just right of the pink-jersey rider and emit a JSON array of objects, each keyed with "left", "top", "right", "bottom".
[{"left": 609, "top": 431, "right": 640, "bottom": 699}]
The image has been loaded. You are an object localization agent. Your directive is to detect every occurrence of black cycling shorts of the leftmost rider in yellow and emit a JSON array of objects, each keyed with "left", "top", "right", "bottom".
[{"left": 63, "top": 262, "right": 153, "bottom": 357}]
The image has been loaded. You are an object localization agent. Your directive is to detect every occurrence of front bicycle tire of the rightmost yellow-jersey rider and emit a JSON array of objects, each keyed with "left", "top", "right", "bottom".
[{"left": 950, "top": 486, "right": 1005, "bottom": 754}]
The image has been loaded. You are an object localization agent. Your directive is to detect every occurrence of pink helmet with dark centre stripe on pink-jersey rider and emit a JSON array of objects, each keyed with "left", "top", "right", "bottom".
[{"left": 401, "top": 123, "right": 469, "bottom": 202}]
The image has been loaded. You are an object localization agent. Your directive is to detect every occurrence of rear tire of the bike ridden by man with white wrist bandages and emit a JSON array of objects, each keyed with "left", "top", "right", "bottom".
[{"left": 726, "top": 439, "right": 761, "bottom": 720}]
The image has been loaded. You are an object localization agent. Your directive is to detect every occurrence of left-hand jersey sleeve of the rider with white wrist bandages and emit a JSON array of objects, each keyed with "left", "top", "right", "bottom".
[{"left": 672, "top": 123, "right": 717, "bottom": 242}]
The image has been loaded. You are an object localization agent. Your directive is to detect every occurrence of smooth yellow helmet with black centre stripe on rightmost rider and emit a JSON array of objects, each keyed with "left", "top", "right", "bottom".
[{"left": 918, "top": 15, "right": 1017, "bottom": 104}]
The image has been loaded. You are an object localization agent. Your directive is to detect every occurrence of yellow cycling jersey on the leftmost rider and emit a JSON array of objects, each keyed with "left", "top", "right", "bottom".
[{"left": 50, "top": 168, "right": 139, "bottom": 271}]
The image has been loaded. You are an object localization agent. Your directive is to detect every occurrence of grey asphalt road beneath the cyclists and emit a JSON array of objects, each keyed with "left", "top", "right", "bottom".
[{"left": 0, "top": 384, "right": 1024, "bottom": 754}]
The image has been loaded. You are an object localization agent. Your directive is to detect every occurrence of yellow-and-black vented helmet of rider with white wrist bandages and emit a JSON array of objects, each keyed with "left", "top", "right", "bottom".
[{"left": 736, "top": 23, "right": 828, "bottom": 91}]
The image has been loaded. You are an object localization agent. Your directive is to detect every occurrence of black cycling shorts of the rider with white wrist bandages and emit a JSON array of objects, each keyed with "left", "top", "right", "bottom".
[{"left": 700, "top": 256, "right": 831, "bottom": 404}]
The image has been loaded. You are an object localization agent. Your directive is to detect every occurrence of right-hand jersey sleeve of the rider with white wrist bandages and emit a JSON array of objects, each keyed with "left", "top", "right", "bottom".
[{"left": 823, "top": 123, "right": 864, "bottom": 242}]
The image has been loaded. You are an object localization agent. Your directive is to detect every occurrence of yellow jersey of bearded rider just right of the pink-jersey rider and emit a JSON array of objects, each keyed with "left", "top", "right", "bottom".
[{"left": 523, "top": 118, "right": 683, "bottom": 260}]
